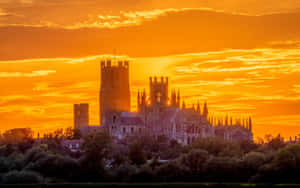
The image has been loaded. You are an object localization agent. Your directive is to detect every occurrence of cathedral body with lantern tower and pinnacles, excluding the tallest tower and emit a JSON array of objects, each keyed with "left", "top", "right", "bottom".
[{"left": 105, "top": 77, "right": 253, "bottom": 145}]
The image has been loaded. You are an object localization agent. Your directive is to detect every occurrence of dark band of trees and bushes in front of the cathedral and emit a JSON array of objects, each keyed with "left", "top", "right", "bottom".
[{"left": 0, "top": 130, "right": 300, "bottom": 184}]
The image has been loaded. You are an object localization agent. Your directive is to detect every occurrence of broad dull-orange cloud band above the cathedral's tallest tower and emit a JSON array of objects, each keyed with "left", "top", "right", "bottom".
[{"left": 0, "top": 9, "right": 300, "bottom": 60}]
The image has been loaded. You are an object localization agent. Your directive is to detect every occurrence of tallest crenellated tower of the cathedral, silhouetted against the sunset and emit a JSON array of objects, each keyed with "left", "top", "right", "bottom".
[{"left": 99, "top": 59, "right": 130, "bottom": 125}]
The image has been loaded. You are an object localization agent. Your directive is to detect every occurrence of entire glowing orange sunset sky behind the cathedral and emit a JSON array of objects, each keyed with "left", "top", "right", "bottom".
[{"left": 0, "top": 0, "right": 300, "bottom": 138}]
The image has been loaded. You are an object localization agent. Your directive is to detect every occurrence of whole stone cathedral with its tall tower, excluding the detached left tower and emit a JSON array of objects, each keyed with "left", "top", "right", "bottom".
[{"left": 77, "top": 60, "right": 253, "bottom": 145}]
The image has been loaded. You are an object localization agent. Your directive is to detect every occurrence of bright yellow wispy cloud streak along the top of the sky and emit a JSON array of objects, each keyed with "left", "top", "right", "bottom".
[{"left": 0, "top": 8, "right": 243, "bottom": 29}]
